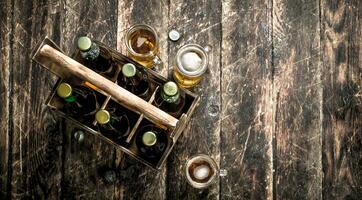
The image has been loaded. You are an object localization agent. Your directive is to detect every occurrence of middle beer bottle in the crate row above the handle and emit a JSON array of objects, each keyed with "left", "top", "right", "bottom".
[{"left": 118, "top": 63, "right": 151, "bottom": 101}]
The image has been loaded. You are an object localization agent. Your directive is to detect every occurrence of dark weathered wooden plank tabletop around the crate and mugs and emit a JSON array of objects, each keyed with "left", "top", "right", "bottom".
[{"left": 0, "top": 0, "right": 362, "bottom": 200}]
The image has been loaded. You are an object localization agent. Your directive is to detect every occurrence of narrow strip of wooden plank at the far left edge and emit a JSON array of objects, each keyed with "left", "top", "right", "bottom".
[{"left": 0, "top": 1, "right": 12, "bottom": 199}]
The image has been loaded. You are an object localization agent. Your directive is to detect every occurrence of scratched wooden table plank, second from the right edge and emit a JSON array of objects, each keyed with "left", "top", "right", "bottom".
[{"left": 273, "top": 0, "right": 323, "bottom": 199}]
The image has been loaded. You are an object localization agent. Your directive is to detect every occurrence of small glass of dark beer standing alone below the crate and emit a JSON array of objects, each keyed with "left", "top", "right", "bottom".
[{"left": 186, "top": 154, "right": 219, "bottom": 189}]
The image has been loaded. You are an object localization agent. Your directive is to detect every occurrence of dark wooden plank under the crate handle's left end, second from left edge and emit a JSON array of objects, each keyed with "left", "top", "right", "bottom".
[{"left": 9, "top": 0, "right": 62, "bottom": 199}]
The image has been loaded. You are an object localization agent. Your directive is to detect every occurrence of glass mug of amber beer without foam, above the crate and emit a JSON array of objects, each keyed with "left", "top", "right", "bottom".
[{"left": 125, "top": 24, "right": 162, "bottom": 68}]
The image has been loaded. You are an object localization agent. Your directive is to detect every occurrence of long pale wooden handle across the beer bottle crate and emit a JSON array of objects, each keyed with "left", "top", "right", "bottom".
[{"left": 38, "top": 44, "right": 178, "bottom": 127}]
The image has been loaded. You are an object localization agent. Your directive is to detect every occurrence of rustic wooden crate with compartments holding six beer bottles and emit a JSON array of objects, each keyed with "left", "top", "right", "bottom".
[{"left": 33, "top": 38, "right": 199, "bottom": 169}]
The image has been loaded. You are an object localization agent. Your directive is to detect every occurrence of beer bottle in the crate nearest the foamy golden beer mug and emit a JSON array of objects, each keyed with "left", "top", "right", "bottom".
[{"left": 155, "top": 81, "right": 185, "bottom": 118}]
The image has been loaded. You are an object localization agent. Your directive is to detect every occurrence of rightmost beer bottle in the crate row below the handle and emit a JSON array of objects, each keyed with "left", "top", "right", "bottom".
[{"left": 136, "top": 124, "right": 167, "bottom": 161}]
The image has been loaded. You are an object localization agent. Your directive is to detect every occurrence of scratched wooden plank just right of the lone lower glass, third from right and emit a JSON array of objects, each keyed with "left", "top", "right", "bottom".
[{"left": 220, "top": 0, "right": 274, "bottom": 199}]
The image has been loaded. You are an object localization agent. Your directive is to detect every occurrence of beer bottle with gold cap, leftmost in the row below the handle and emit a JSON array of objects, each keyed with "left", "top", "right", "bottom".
[{"left": 57, "top": 83, "right": 98, "bottom": 117}]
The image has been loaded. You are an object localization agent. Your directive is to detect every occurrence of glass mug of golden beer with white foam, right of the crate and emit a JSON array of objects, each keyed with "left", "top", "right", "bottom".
[{"left": 173, "top": 44, "right": 209, "bottom": 88}]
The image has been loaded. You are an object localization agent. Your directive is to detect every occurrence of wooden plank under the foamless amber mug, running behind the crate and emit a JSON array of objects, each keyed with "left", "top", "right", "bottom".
[{"left": 116, "top": 0, "right": 169, "bottom": 200}]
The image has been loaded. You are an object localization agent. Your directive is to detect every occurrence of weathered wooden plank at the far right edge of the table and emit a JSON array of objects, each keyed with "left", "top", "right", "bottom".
[{"left": 321, "top": 0, "right": 362, "bottom": 199}]
